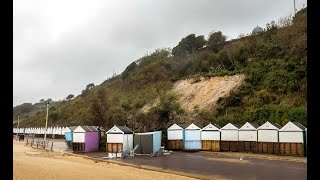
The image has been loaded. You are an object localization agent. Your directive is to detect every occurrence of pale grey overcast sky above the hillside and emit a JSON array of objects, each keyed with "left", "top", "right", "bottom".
[{"left": 13, "top": 0, "right": 307, "bottom": 106}]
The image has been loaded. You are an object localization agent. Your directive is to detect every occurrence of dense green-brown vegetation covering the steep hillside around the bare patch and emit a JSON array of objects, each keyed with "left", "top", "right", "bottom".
[{"left": 14, "top": 8, "right": 307, "bottom": 131}]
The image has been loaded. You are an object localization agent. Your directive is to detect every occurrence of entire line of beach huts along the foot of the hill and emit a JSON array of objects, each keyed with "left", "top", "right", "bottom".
[{"left": 13, "top": 121, "right": 307, "bottom": 157}]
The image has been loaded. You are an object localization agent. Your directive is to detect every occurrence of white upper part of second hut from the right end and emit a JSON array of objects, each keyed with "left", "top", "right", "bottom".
[{"left": 258, "top": 121, "right": 281, "bottom": 142}]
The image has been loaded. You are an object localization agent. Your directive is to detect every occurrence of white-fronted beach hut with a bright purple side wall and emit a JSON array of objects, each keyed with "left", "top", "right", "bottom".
[{"left": 72, "top": 126, "right": 99, "bottom": 152}]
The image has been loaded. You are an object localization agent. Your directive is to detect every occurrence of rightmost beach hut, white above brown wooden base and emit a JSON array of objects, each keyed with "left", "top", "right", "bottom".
[{"left": 279, "top": 121, "right": 306, "bottom": 156}]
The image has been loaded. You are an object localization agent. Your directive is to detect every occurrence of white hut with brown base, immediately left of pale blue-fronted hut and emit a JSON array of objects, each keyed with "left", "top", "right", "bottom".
[{"left": 167, "top": 124, "right": 184, "bottom": 150}]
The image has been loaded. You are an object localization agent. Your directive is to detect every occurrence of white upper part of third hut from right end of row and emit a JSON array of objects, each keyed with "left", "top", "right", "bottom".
[{"left": 239, "top": 122, "right": 259, "bottom": 141}]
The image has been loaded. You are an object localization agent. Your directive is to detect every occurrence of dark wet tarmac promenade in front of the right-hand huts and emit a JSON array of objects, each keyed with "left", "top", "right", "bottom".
[{"left": 116, "top": 152, "right": 307, "bottom": 180}]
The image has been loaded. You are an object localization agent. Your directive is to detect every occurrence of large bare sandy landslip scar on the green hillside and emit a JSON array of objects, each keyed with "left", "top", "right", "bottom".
[{"left": 173, "top": 74, "right": 245, "bottom": 112}]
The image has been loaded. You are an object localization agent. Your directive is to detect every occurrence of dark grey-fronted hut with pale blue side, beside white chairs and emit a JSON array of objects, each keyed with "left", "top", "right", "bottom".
[{"left": 134, "top": 131, "right": 162, "bottom": 154}]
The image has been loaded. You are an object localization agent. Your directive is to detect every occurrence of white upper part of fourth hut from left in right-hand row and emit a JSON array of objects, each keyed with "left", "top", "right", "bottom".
[{"left": 220, "top": 123, "right": 239, "bottom": 141}]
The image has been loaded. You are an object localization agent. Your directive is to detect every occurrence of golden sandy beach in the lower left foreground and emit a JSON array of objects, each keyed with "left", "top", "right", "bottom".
[{"left": 13, "top": 141, "right": 192, "bottom": 180}]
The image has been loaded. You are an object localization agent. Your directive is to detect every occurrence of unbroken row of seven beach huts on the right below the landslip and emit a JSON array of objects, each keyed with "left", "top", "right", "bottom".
[{"left": 168, "top": 121, "right": 307, "bottom": 156}]
